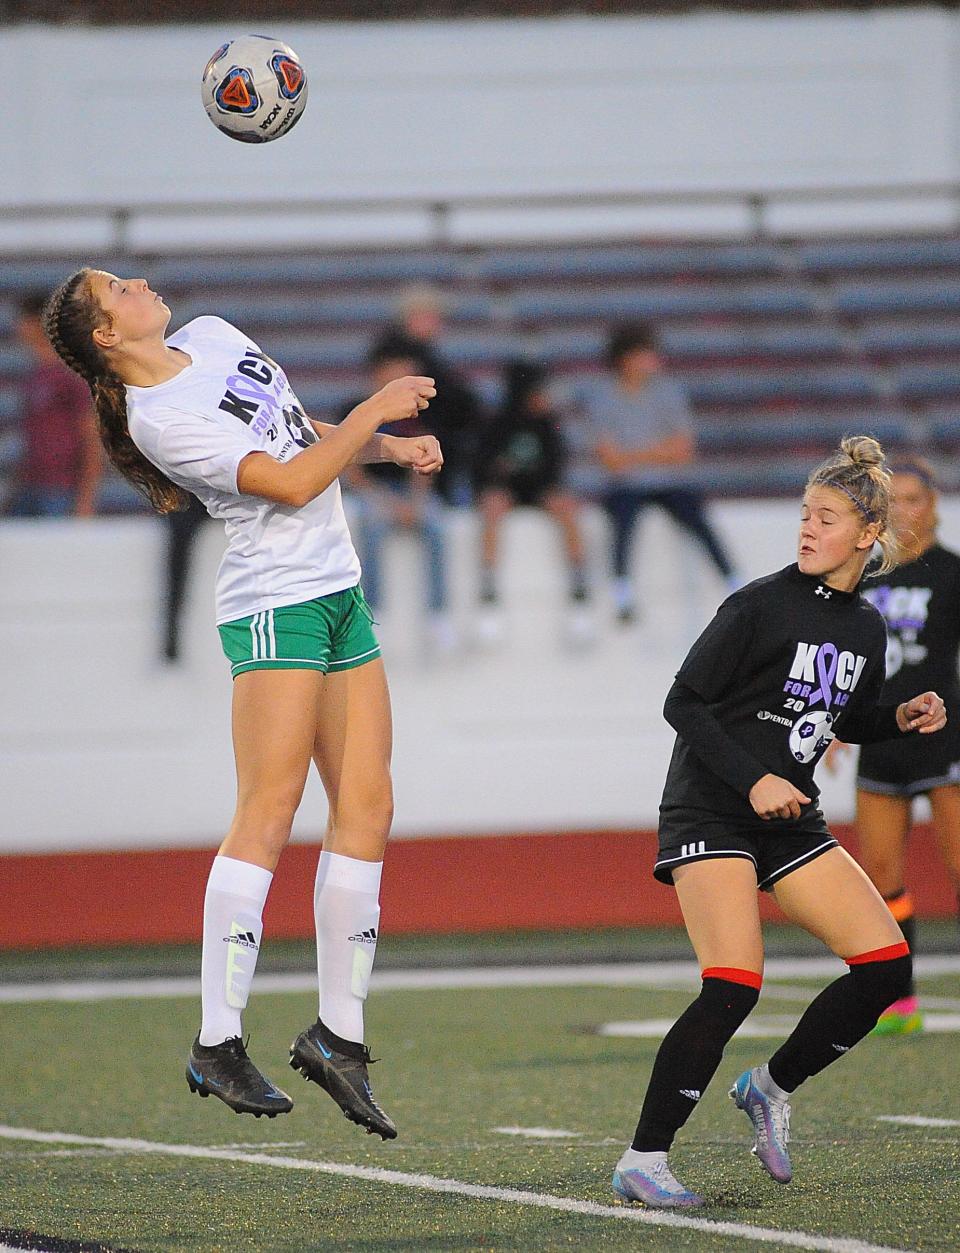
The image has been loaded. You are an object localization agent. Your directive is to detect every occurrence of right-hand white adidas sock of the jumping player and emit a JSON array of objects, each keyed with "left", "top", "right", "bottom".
[{"left": 313, "top": 852, "right": 383, "bottom": 1044}]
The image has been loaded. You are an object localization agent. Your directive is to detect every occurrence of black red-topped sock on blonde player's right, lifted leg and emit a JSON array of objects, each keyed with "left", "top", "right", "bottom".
[{"left": 770, "top": 944, "right": 912, "bottom": 1093}]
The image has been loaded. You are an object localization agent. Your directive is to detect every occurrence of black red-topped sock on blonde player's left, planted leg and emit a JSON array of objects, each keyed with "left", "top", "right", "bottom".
[{"left": 632, "top": 967, "right": 759, "bottom": 1153}]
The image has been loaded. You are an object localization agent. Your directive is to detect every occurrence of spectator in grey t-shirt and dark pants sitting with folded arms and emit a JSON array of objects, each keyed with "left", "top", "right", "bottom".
[{"left": 578, "top": 322, "right": 736, "bottom": 623}]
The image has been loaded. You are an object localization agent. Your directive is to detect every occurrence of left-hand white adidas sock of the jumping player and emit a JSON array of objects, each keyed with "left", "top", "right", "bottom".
[{"left": 201, "top": 856, "right": 273, "bottom": 1045}]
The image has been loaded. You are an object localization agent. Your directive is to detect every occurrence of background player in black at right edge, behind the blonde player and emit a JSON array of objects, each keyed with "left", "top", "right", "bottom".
[{"left": 827, "top": 457, "right": 960, "bottom": 1035}]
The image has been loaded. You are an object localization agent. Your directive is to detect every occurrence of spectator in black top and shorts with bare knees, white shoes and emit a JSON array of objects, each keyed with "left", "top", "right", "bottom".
[{"left": 474, "top": 361, "right": 593, "bottom": 643}]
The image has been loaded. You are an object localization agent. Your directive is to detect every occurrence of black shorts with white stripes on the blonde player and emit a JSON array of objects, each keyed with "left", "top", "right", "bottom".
[{"left": 653, "top": 809, "right": 838, "bottom": 892}]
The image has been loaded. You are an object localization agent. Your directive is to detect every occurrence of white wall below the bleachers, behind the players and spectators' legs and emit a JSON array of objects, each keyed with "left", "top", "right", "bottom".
[{"left": 0, "top": 499, "right": 960, "bottom": 852}]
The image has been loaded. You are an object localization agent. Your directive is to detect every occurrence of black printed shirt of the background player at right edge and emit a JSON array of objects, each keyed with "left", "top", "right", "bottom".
[{"left": 863, "top": 544, "right": 960, "bottom": 710}]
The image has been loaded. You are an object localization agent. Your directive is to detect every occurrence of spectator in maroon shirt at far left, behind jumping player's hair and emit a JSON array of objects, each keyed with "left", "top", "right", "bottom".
[{"left": 9, "top": 294, "right": 103, "bottom": 517}]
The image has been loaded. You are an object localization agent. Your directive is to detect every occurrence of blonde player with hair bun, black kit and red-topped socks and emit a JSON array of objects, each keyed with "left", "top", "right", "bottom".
[{"left": 613, "top": 437, "right": 946, "bottom": 1208}]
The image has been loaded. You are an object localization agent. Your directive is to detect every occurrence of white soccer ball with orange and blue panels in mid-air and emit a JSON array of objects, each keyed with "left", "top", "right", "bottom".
[{"left": 201, "top": 35, "right": 307, "bottom": 144}]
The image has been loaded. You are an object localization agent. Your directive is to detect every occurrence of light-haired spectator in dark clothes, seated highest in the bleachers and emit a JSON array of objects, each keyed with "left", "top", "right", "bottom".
[{"left": 392, "top": 287, "right": 481, "bottom": 505}]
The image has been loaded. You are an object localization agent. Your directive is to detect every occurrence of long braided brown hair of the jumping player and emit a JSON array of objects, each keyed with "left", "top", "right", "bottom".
[{"left": 41, "top": 269, "right": 187, "bottom": 514}]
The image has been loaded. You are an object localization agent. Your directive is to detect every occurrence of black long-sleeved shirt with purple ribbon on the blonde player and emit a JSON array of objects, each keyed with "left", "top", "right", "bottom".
[{"left": 660, "top": 565, "right": 915, "bottom": 827}]
